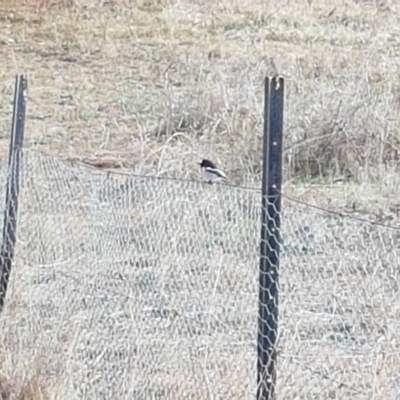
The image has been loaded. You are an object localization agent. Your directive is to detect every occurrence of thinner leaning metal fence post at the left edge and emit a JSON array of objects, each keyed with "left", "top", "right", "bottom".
[{"left": 0, "top": 75, "right": 28, "bottom": 313}]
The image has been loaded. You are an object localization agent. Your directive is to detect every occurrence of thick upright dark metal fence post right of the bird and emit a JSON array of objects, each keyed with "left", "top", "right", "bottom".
[{"left": 257, "top": 77, "right": 284, "bottom": 400}]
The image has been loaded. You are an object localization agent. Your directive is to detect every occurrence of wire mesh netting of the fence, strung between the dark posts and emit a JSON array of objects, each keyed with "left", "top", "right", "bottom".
[{"left": 0, "top": 150, "right": 400, "bottom": 400}]
